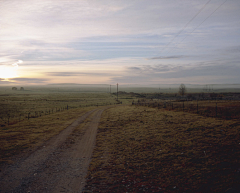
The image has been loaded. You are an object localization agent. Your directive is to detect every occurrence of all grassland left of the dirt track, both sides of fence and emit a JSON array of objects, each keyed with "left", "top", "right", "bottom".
[{"left": 0, "top": 91, "right": 135, "bottom": 163}]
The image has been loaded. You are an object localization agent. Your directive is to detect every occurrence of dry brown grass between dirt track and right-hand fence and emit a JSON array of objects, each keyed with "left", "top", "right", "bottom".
[{"left": 84, "top": 106, "right": 240, "bottom": 192}]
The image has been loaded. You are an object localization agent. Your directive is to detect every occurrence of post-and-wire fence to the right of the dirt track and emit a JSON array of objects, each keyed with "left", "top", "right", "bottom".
[{"left": 132, "top": 101, "right": 240, "bottom": 120}]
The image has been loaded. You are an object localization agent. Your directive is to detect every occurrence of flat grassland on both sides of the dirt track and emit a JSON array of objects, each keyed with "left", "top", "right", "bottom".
[{"left": 0, "top": 90, "right": 240, "bottom": 192}]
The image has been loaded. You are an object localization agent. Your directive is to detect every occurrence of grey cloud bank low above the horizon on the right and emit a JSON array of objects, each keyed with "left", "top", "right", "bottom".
[{"left": 123, "top": 61, "right": 240, "bottom": 83}]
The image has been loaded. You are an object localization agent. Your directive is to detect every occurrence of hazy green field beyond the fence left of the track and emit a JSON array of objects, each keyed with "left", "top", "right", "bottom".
[{"left": 0, "top": 90, "right": 134, "bottom": 127}]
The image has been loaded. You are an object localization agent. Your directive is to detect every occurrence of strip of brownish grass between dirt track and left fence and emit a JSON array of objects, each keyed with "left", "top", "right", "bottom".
[{"left": 0, "top": 107, "right": 96, "bottom": 164}]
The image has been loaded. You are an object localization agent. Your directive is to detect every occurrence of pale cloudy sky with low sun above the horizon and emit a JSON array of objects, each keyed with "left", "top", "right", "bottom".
[{"left": 0, "top": 0, "right": 240, "bottom": 85}]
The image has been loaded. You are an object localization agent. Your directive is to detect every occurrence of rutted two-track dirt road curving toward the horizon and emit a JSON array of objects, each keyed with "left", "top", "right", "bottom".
[{"left": 0, "top": 109, "right": 104, "bottom": 193}]
